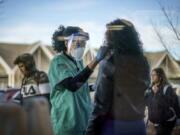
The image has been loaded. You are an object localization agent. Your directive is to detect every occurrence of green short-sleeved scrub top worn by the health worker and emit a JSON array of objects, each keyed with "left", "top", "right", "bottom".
[{"left": 48, "top": 53, "right": 92, "bottom": 135}]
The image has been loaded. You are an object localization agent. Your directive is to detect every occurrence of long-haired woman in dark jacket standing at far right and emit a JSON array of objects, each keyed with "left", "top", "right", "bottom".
[{"left": 147, "top": 68, "right": 180, "bottom": 135}]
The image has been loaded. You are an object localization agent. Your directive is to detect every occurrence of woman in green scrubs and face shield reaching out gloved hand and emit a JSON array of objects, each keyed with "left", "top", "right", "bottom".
[{"left": 48, "top": 26, "right": 107, "bottom": 135}]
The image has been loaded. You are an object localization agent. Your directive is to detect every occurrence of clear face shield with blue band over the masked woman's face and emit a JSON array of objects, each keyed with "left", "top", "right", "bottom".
[{"left": 68, "top": 32, "right": 89, "bottom": 61}]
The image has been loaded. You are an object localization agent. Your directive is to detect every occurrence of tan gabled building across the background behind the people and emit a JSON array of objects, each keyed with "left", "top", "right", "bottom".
[{"left": 0, "top": 42, "right": 180, "bottom": 92}]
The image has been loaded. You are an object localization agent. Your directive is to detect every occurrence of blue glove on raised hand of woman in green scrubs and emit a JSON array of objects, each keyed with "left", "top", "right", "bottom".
[{"left": 96, "top": 46, "right": 108, "bottom": 62}]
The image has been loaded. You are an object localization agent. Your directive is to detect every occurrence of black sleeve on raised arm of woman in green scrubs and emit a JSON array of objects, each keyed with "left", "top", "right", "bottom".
[{"left": 60, "top": 66, "right": 93, "bottom": 92}]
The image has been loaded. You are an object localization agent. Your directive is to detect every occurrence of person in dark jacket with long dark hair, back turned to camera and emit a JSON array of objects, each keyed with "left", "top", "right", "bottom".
[{"left": 86, "top": 19, "right": 150, "bottom": 135}]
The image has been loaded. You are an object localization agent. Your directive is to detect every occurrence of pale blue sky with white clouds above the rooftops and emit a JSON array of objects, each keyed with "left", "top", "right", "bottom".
[{"left": 0, "top": 0, "right": 180, "bottom": 57}]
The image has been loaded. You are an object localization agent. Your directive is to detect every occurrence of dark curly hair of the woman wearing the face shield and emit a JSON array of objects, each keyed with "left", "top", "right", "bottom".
[{"left": 52, "top": 25, "right": 82, "bottom": 52}]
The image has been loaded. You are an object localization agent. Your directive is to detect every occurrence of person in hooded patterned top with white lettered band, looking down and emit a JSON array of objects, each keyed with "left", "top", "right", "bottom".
[{"left": 14, "top": 53, "right": 51, "bottom": 103}]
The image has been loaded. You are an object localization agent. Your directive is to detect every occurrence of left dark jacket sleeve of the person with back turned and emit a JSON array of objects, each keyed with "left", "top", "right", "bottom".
[{"left": 86, "top": 57, "right": 113, "bottom": 135}]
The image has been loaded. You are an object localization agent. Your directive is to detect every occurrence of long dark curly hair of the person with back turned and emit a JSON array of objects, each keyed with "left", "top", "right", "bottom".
[{"left": 106, "top": 19, "right": 143, "bottom": 55}]
